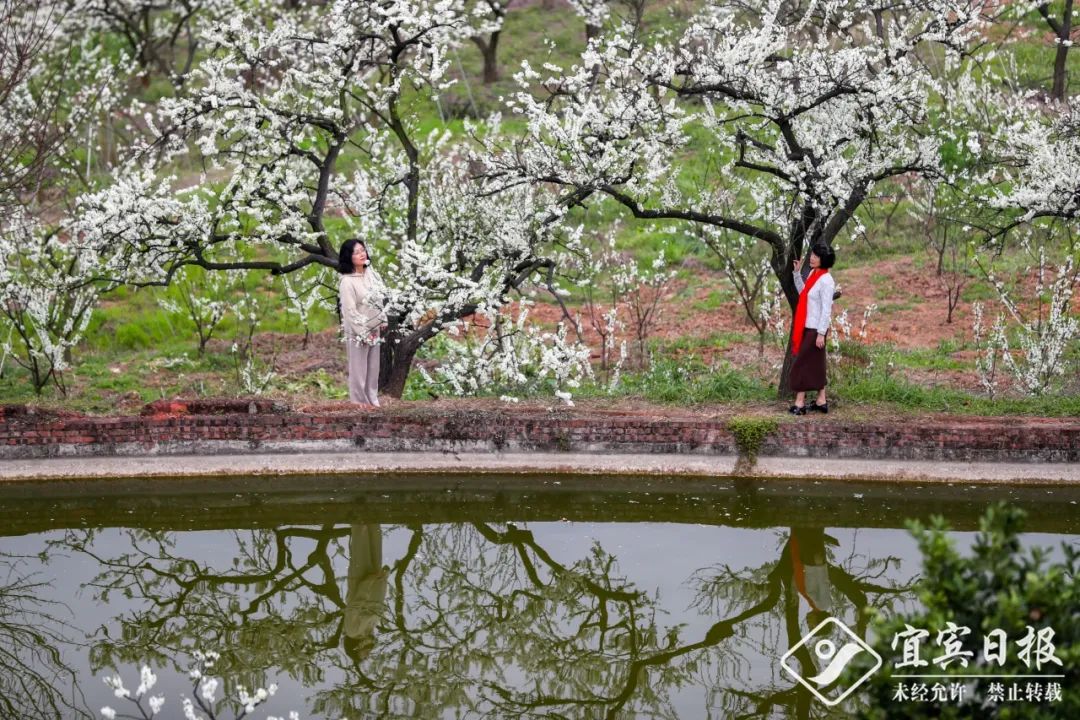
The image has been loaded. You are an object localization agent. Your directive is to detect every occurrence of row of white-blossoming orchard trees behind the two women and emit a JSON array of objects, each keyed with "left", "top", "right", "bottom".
[{"left": 0, "top": 0, "right": 1080, "bottom": 396}]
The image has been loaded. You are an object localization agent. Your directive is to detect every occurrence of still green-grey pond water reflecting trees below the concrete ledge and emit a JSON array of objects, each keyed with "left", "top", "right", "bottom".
[{"left": 0, "top": 476, "right": 1080, "bottom": 720}]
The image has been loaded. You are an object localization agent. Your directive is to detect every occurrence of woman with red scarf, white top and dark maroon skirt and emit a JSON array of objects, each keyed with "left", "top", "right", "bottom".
[{"left": 788, "top": 244, "right": 836, "bottom": 415}]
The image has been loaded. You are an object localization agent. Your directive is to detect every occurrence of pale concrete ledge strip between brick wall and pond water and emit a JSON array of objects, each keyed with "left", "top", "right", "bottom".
[{"left": 0, "top": 451, "right": 1080, "bottom": 485}]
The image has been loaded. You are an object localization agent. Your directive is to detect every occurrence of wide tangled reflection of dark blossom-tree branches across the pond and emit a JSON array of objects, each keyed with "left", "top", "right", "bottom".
[{"left": 68, "top": 522, "right": 908, "bottom": 718}]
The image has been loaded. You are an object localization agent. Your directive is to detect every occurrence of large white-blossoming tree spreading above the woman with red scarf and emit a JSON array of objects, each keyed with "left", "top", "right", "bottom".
[{"left": 491, "top": 0, "right": 991, "bottom": 392}]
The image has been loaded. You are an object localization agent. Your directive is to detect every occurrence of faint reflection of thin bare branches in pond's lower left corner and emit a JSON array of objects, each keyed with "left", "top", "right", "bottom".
[{"left": 0, "top": 554, "right": 92, "bottom": 720}]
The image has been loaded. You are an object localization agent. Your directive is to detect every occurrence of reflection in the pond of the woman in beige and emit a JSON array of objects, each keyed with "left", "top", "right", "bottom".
[{"left": 343, "top": 525, "right": 389, "bottom": 663}]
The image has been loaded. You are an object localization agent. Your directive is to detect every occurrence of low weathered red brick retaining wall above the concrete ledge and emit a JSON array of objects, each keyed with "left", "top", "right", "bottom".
[{"left": 0, "top": 399, "right": 1080, "bottom": 462}]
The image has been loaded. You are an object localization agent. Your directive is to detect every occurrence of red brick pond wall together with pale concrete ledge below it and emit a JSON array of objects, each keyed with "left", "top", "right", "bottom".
[{"left": 0, "top": 399, "right": 1080, "bottom": 484}]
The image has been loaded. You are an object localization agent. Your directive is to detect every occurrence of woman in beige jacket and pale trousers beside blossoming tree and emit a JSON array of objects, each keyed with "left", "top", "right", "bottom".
[{"left": 338, "top": 240, "right": 387, "bottom": 407}]
